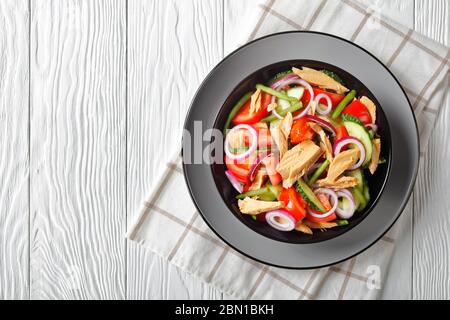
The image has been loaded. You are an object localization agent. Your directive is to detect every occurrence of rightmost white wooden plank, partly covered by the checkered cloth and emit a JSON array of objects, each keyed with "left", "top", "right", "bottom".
[{"left": 413, "top": 0, "right": 450, "bottom": 299}]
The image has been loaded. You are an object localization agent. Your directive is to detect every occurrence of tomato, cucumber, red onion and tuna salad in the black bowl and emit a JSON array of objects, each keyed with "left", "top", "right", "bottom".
[{"left": 224, "top": 67, "right": 383, "bottom": 234}]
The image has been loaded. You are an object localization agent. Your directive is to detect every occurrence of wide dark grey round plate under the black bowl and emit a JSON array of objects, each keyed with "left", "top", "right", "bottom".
[{"left": 183, "top": 31, "right": 419, "bottom": 269}]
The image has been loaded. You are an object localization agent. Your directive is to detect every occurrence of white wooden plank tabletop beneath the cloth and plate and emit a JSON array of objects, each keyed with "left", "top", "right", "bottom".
[{"left": 0, "top": 0, "right": 450, "bottom": 299}]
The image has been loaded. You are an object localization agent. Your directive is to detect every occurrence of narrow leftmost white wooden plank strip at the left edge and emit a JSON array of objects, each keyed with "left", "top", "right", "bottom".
[{"left": 0, "top": 0, "right": 29, "bottom": 300}]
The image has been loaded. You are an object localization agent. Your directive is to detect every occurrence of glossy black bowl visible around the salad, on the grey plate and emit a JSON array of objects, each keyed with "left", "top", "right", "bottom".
[{"left": 211, "top": 60, "right": 391, "bottom": 243}]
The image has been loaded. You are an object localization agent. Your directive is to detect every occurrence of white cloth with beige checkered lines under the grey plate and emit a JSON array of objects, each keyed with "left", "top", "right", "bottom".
[{"left": 128, "top": 0, "right": 450, "bottom": 299}]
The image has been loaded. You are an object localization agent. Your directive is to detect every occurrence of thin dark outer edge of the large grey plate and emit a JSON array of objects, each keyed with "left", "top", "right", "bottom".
[{"left": 181, "top": 30, "right": 420, "bottom": 270}]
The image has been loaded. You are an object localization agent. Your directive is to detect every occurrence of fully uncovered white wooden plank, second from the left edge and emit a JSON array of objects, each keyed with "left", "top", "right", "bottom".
[{"left": 30, "top": 0, "right": 126, "bottom": 299}]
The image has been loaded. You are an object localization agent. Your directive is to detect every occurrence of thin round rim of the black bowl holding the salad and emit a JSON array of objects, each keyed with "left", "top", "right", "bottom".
[{"left": 210, "top": 59, "right": 392, "bottom": 244}]
